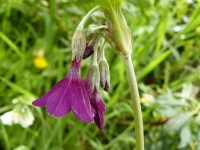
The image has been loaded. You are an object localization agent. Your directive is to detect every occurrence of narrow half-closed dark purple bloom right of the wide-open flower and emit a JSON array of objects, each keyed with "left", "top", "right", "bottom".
[{"left": 90, "top": 90, "right": 106, "bottom": 131}]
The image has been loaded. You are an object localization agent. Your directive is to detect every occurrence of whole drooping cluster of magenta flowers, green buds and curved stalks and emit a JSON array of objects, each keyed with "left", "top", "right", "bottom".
[{"left": 32, "top": 6, "right": 114, "bottom": 130}]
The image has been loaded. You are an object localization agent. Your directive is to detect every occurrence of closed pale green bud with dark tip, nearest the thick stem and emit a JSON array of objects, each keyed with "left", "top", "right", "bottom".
[{"left": 99, "top": 59, "right": 110, "bottom": 92}]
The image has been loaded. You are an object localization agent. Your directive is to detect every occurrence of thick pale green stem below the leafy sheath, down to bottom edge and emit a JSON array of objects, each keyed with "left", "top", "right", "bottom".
[{"left": 122, "top": 55, "right": 144, "bottom": 150}]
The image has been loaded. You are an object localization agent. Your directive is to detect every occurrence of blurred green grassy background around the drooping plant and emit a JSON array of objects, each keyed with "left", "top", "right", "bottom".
[{"left": 0, "top": 0, "right": 200, "bottom": 150}]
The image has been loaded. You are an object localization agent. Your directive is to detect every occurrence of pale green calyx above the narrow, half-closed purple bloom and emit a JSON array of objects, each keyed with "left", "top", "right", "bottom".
[{"left": 88, "top": 65, "right": 100, "bottom": 93}]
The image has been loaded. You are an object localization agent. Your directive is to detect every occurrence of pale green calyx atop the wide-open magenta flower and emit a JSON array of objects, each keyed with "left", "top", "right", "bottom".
[{"left": 72, "top": 27, "right": 86, "bottom": 60}]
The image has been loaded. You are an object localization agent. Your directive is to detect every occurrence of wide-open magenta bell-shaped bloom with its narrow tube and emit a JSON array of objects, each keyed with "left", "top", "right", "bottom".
[{"left": 32, "top": 59, "right": 95, "bottom": 123}]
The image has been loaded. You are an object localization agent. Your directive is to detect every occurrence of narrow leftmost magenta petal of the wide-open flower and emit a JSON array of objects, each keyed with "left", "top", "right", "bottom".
[{"left": 32, "top": 77, "right": 66, "bottom": 106}]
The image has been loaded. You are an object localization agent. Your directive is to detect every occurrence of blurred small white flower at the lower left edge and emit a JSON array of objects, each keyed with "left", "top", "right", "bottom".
[{"left": 0, "top": 105, "right": 34, "bottom": 128}]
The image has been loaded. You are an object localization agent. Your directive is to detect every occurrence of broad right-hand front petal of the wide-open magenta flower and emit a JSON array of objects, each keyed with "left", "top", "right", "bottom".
[{"left": 71, "top": 80, "right": 95, "bottom": 123}]
